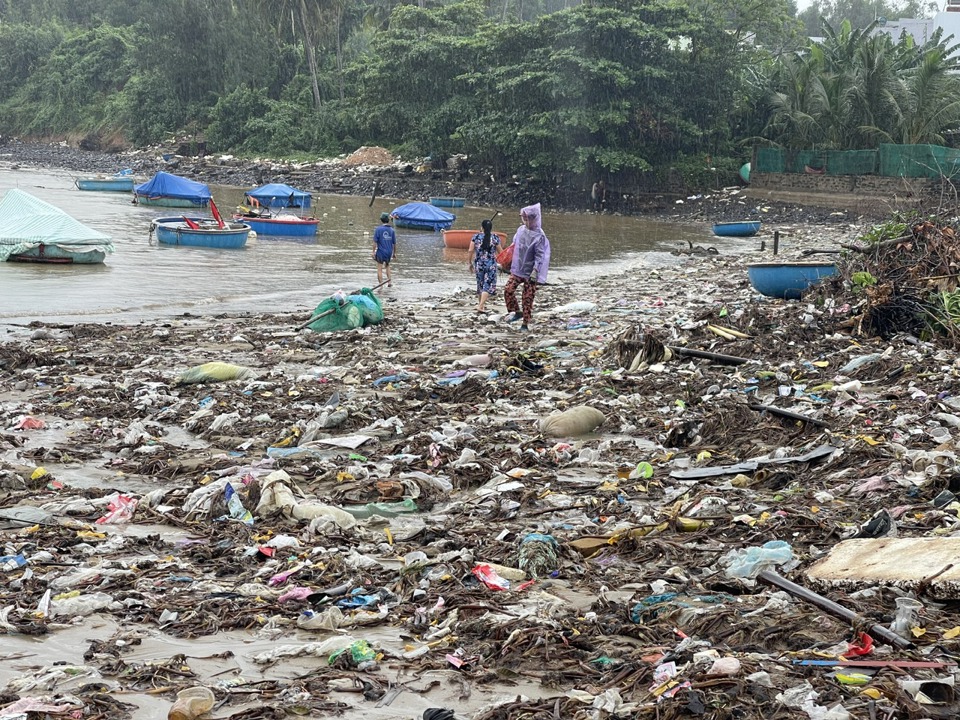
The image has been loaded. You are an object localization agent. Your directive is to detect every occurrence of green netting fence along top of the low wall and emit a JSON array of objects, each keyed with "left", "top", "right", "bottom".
[{"left": 753, "top": 144, "right": 960, "bottom": 178}]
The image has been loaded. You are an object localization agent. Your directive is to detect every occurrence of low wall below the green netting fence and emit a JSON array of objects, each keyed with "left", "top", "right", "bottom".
[{"left": 747, "top": 172, "right": 957, "bottom": 213}]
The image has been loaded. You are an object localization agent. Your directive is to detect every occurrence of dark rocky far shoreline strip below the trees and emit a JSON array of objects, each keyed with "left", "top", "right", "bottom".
[{"left": 0, "top": 139, "right": 887, "bottom": 226}]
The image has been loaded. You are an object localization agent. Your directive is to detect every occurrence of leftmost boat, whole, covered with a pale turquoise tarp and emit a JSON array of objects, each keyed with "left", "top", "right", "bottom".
[{"left": 0, "top": 188, "right": 114, "bottom": 265}]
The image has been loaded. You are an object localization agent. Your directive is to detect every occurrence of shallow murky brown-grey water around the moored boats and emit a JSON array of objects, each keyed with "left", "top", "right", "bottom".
[{"left": 0, "top": 164, "right": 734, "bottom": 323}]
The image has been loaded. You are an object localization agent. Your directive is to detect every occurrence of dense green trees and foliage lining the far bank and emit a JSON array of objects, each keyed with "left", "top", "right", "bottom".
[{"left": 0, "top": 0, "right": 960, "bottom": 187}]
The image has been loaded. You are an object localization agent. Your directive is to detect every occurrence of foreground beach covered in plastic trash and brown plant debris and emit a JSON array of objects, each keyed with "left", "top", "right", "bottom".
[{"left": 9, "top": 219, "right": 960, "bottom": 720}]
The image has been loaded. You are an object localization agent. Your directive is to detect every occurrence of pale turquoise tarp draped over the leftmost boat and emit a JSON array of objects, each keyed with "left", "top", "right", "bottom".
[{"left": 0, "top": 188, "right": 114, "bottom": 261}]
